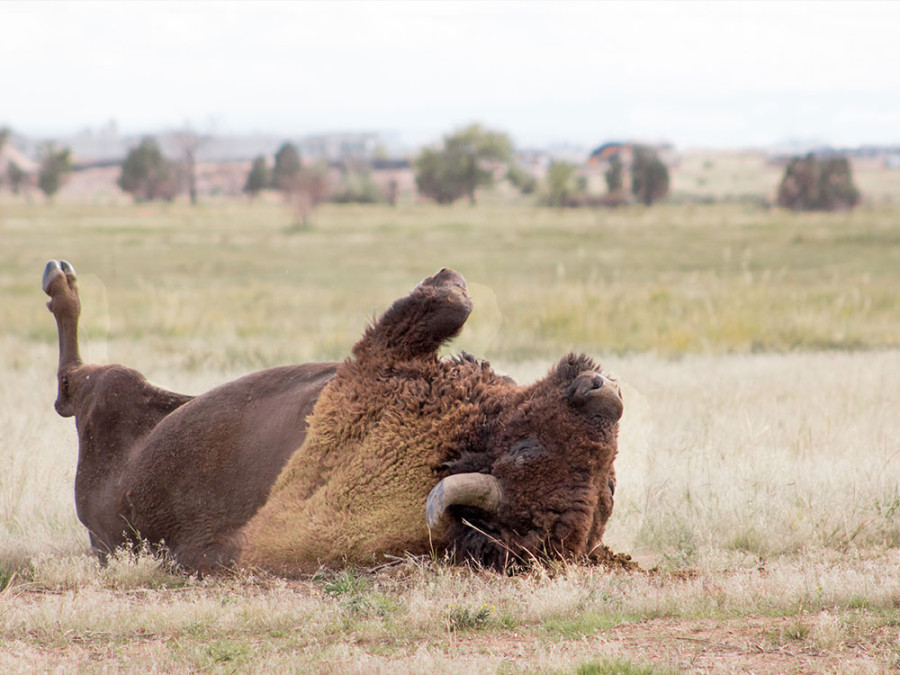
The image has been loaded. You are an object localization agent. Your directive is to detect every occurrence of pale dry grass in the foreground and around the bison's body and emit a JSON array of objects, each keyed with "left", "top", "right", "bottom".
[{"left": 0, "top": 348, "right": 900, "bottom": 672}]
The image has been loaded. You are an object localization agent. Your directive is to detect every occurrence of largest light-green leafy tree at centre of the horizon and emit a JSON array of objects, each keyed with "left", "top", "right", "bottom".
[{"left": 415, "top": 124, "right": 512, "bottom": 204}]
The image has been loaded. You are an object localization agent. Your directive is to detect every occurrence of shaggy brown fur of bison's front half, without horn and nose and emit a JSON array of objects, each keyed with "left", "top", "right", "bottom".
[{"left": 240, "top": 270, "right": 621, "bottom": 574}]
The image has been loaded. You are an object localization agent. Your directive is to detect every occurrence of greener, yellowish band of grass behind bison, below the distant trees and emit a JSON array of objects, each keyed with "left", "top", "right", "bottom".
[{"left": 0, "top": 203, "right": 900, "bottom": 369}]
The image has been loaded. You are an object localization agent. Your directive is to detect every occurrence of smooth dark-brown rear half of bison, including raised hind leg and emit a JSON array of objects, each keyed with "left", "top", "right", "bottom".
[{"left": 45, "top": 263, "right": 337, "bottom": 572}]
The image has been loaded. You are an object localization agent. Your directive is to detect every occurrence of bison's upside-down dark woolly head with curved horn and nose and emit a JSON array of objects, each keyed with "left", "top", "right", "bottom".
[{"left": 426, "top": 355, "right": 623, "bottom": 567}]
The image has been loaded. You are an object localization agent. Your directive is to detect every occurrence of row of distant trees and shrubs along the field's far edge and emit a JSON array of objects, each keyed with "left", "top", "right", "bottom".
[{"left": 0, "top": 124, "right": 861, "bottom": 213}]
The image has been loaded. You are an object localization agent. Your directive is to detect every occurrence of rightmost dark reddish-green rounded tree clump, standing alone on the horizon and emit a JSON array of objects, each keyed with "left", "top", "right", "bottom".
[{"left": 778, "top": 153, "right": 860, "bottom": 211}]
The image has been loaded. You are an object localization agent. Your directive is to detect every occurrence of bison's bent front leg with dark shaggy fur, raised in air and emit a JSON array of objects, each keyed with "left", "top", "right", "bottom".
[{"left": 353, "top": 269, "right": 472, "bottom": 360}]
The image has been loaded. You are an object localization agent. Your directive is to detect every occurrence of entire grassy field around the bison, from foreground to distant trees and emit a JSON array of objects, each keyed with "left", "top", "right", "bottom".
[{"left": 0, "top": 198, "right": 900, "bottom": 673}]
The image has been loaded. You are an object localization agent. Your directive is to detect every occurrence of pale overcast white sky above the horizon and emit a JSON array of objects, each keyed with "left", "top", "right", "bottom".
[{"left": 0, "top": 0, "right": 900, "bottom": 148}]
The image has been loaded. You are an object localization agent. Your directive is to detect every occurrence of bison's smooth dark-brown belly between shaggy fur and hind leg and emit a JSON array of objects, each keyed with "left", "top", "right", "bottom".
[{"left": 124, "top": 364, "right": 335, "bottom": 571}]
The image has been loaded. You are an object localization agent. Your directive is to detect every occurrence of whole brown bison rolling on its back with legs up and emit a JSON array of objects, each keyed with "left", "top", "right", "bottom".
[{"left": 43, "top": 261, "right": 623, "bottom": 576}]
